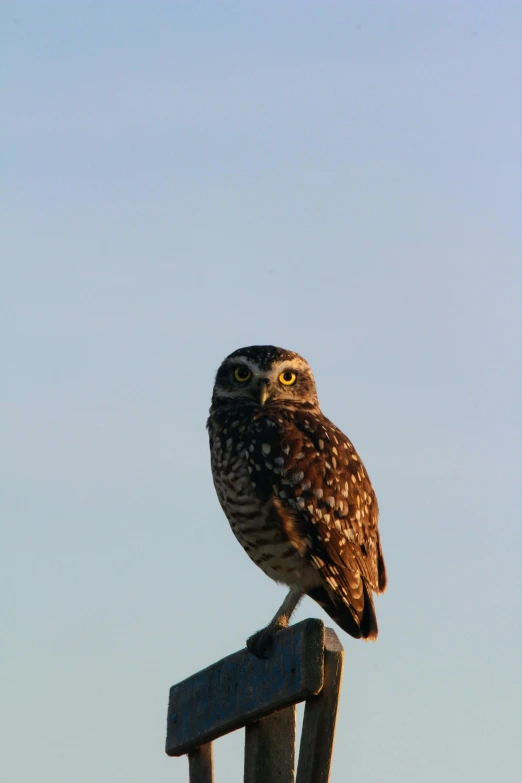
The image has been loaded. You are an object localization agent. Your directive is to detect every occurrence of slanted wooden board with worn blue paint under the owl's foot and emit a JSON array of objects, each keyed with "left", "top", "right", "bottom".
[{"left": 165, "top": 619, "right": 324, "bottom": 756}]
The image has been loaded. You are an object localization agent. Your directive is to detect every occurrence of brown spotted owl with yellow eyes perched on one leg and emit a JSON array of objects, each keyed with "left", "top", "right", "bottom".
[{"left": 207, "top": 345, "right": 386, "bottom": 657}]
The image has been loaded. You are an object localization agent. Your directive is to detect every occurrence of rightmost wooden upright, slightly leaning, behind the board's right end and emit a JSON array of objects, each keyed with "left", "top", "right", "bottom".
[{"left": 296, "top": 628, "right": 344, "bottom": 783}]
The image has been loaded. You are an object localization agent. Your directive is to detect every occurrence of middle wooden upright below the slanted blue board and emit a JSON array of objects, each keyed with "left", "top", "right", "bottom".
[{"left": 243, "top": 704, "right": 295, "bottom": 783}]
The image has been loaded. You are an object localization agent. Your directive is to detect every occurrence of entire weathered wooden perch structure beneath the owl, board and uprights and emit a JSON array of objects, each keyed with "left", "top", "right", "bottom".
[{"left": 165, "top": 620, "right": 343, "bottom": 783}]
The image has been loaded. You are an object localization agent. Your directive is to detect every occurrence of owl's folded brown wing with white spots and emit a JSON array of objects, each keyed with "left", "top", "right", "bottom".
[{"left": 248, "top": 409, "right": 386, "bottom": 638}]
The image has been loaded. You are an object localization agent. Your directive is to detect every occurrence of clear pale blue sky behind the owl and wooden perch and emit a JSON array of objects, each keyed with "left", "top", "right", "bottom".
[{"left": 0, "top": 0, "right": 522, "bottom": 783}]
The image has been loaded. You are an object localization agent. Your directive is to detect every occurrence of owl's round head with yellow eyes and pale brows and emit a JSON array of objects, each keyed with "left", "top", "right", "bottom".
[{"left": 212, "top": 345, "right": 319, "bottom": 410}]
